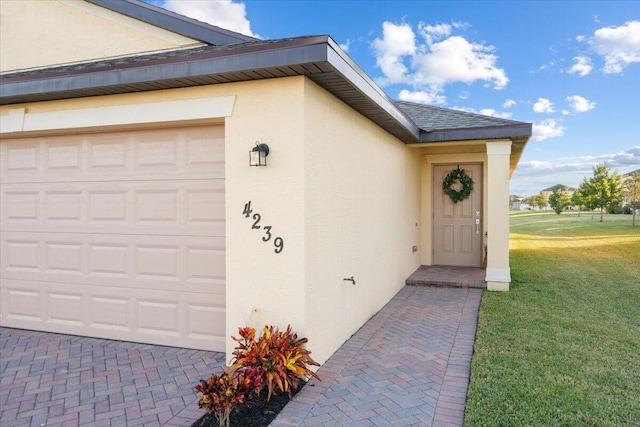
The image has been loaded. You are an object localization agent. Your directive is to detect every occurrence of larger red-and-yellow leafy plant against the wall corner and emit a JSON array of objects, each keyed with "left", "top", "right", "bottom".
[{"left": 231, "top": 326, "right": 320, "bottom": 400}]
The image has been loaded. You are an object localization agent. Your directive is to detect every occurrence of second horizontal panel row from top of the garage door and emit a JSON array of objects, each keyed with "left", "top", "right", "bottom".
[{"left": 0, "top": 180, "right": 225, "bottom": 236}]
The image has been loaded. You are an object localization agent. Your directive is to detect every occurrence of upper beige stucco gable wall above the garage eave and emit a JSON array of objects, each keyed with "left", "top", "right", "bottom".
[{"left": 0, "top": 0, "right": 202, "bottom": 72}]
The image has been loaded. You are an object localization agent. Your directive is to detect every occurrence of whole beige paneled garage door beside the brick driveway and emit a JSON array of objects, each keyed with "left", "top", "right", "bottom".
[{"left": 0, "top": 126, "right": 225, "bottom": 351}]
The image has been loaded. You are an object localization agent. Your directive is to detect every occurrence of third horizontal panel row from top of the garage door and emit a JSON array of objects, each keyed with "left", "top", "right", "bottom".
[{"left": 2, "top": 232, "right": 225, "bottom": 295}]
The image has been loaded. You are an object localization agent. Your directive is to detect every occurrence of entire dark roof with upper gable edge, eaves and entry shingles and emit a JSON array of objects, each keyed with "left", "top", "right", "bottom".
[{"left": 0, "top": 0, "right": 532, "bottom": 144}]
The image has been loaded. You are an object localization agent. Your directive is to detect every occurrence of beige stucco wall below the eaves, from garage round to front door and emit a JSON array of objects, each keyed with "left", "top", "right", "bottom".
[{"left": 0, "top": 76, "right": 508, "bottom": 362}]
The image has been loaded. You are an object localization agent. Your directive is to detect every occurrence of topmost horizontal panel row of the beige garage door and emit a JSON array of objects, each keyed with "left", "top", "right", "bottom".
[{"left": 0, "top": 126, "right": 224, "bottom": 182}]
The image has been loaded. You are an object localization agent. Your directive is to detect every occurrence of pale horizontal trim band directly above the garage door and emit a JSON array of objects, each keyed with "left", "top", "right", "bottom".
[{"left": 0, "top": 96, "right": 235, "bottom": 137}]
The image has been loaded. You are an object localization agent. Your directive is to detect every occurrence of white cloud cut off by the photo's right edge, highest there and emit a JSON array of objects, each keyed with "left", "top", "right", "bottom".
[{"left": 589, "top": 21, "right": 640, "bottom": 74}]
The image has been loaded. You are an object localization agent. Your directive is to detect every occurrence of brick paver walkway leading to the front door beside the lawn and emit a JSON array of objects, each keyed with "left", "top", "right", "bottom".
[{"left": 271, "top": 286, "right": 482, "bottom": 427}]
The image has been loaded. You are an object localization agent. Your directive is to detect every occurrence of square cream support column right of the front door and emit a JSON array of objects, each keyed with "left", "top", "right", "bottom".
[{"left": 485, "top": 141, "right": 511, "bottom": 291}]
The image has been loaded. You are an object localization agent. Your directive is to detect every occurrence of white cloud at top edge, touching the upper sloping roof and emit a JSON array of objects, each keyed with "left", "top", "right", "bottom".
[{"left": 159, "top": 0, "right": 259, "bottom": 38}]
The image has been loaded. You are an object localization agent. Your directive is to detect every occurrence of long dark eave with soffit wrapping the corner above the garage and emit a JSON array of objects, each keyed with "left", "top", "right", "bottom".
[{"left": 0, "top": 36, "right": 420, "bottom": 143}]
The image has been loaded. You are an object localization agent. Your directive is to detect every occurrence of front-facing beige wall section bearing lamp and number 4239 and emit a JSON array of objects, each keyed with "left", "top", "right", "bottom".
[{"left": 226, "top": 77, "right": 310, "bottom": 355}]
